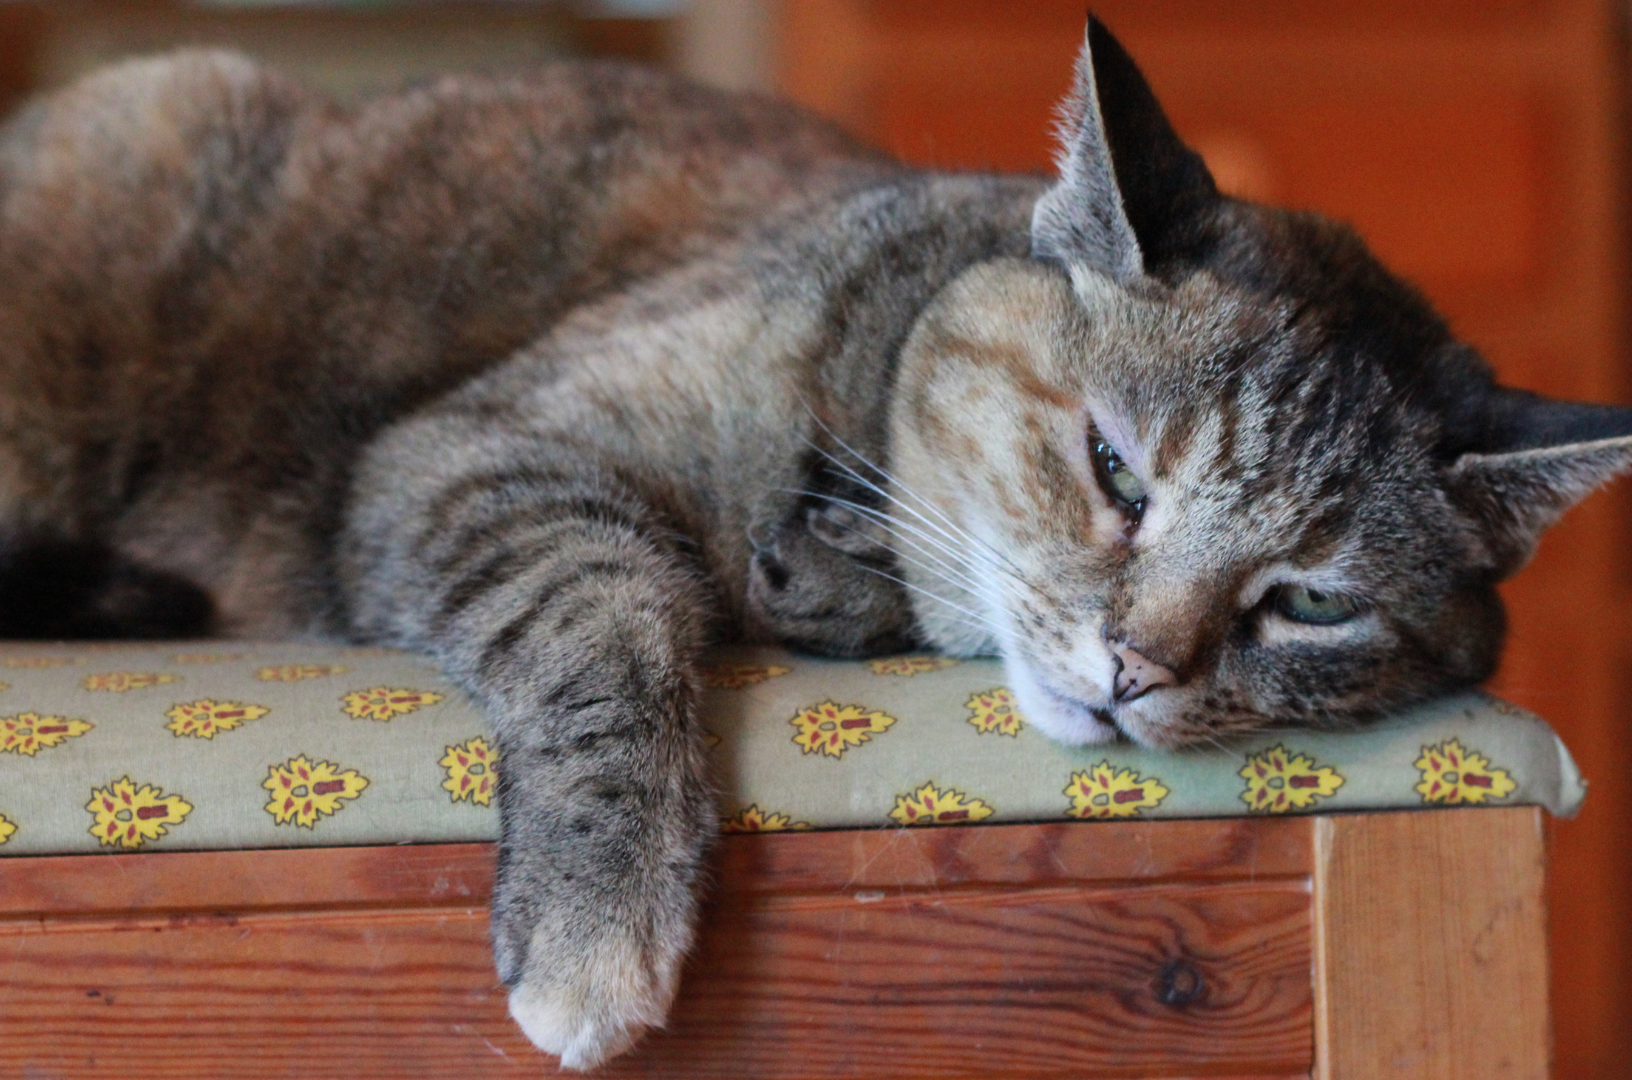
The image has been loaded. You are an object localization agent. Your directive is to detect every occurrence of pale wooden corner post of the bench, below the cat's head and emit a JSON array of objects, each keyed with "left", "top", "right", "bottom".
[{"left": 1315, "top": 808, "right": 1550, "bottom": 1080}]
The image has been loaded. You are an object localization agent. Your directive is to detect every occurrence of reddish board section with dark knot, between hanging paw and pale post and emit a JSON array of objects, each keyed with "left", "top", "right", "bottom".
[{"left": 609, "top": 883, "right": 1310, "bottom": 1080}]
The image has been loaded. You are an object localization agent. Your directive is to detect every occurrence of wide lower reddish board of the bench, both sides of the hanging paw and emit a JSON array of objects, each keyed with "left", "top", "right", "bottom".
[{"left": 0, "top": 884, "right": 1310, "bottom": 1080}]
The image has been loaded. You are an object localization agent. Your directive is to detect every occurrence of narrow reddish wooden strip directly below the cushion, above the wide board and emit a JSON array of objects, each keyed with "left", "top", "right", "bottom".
[{"left": 0, "top": 819, "right": 1312, "bottom": 920}]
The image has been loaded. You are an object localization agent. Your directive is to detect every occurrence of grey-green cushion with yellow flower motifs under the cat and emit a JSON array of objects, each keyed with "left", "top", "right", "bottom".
[{"left": 0, "top": 643, "right": 1583, "bottom": 855}]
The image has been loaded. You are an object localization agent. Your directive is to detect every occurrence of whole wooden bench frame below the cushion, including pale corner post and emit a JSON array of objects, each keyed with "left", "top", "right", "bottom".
[{"left": 0, "top": 808, "right": 1549, "bottom": 1080}]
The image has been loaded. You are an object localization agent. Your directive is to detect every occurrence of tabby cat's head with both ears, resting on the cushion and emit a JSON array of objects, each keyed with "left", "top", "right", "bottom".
[{"left": 891, "top": 23, "right": 1632, "bottom": 746}]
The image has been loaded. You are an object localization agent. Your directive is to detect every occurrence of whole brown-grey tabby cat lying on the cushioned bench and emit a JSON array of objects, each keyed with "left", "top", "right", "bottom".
[{"left": 0, "top": 21, "right": 1632, "bottom": 1069}]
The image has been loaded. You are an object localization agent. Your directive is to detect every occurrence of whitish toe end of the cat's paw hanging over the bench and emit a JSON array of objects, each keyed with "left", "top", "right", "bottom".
[{"left": 509, "top": 927, "right": 685, "bottom": 1069}]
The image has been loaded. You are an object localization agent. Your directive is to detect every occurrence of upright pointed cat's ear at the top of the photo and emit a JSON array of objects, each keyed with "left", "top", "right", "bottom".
[{"left": 1031, "top": 15, "right": 1219, "bottom": 284}]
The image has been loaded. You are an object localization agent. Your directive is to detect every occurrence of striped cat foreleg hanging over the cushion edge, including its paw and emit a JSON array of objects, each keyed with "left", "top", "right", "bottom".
[{"left": 343, "top": 423, "right": 718, "bottom": 1069}]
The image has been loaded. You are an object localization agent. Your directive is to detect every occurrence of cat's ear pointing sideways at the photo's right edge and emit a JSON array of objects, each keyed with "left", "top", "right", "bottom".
[{"left": 1446, "top": 387, "right": 1632, "bottom": 578}]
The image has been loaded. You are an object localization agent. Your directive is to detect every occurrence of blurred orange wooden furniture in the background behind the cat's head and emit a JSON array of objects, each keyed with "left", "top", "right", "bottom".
[{"left": 780, "top": 0, "right": 1632, "bottom": 1080}]
